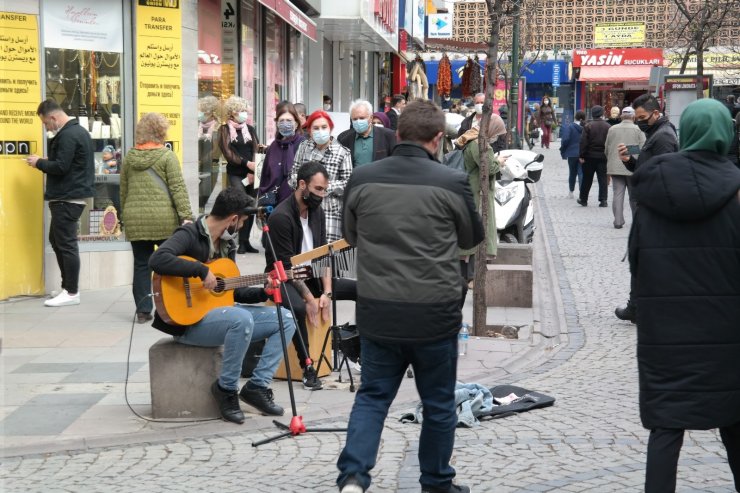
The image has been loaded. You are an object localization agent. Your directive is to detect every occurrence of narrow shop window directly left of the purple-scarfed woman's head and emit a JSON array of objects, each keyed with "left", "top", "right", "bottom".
[{"left": 265, "top": 11, "right": 288, "bottom": 144}]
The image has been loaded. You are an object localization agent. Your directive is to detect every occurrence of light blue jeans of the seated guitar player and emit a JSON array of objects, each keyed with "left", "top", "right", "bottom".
[{"left": 175, "top": 304, "right": 295, "bottom": 391}]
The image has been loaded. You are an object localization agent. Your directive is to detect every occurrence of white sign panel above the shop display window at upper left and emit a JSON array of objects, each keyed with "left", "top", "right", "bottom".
[{"left": 43, "top": 0, "right": 123, "bottom": 53}]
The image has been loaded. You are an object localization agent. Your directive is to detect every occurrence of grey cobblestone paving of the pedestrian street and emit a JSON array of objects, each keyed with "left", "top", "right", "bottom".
[{"left": 2, "top": 144, "right": 733, "bottom": 493}]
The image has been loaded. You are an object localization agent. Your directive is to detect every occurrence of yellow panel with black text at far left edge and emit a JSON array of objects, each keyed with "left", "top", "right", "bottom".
[{"left": 0, "top": 12, "right": 44, "bottom": 300}]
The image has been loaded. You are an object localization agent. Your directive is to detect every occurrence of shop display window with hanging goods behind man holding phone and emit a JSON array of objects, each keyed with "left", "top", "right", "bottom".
[{"left": 45, "top": 48, "right": 124, "bottom": 242}]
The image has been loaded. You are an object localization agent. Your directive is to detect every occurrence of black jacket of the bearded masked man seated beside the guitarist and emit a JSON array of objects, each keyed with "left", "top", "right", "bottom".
[{"left": 265, "top": 194, "right": 326, "bottom": 270}]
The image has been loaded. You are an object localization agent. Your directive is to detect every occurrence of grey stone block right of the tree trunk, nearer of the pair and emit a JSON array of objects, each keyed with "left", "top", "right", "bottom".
[{"left": 486, "top": 264, "right": 533, "bottom": 308}]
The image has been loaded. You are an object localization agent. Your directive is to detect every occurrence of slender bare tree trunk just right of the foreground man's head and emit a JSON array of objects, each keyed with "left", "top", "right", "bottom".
[{"left": 473, "top": 0, "right": 504, "bottom": 336}]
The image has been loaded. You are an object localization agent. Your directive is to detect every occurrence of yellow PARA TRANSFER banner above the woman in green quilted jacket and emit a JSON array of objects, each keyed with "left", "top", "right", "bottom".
[{"left": 136, "top": 0, "right": 183, "bottom": 166}]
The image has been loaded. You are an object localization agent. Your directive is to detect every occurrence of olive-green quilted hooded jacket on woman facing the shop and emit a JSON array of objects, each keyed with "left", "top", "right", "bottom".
[{"left": 121, "top": 147, "right": 193, "bottom": 241}]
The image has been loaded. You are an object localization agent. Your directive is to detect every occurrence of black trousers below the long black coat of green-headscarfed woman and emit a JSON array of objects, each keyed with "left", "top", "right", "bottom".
[{"left": 645, "top": 422, "right": 740, "bottom": 493}]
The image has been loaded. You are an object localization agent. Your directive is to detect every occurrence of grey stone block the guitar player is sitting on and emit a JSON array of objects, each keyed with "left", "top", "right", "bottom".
[{"left": 149, "top": 337, "right": 224, "bottom": 419}]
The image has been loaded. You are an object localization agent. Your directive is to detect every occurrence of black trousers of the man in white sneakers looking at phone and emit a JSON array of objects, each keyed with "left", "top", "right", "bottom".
[{"left": 49, "top": 201, "right": 85, "bottom": 294}]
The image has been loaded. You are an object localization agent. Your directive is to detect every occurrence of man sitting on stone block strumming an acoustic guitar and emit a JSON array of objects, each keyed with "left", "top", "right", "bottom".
[{"left": 149, "top": 187, "right": 295, "bottom": 424}]
